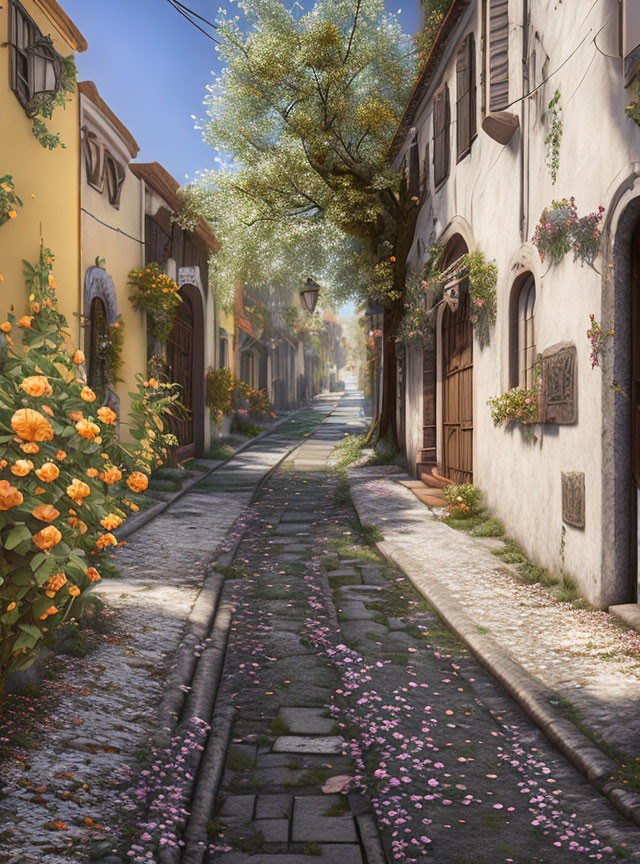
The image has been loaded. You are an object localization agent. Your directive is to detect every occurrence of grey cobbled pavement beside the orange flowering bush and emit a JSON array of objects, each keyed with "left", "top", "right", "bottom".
[{"left": 0, "top": 400, "right": 334, "bottom": 864}]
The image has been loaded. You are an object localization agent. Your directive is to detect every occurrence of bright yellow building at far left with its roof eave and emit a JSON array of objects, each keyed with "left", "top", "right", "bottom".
[{"left": 0, "top": 0, "right": 87, "bottom": 332}]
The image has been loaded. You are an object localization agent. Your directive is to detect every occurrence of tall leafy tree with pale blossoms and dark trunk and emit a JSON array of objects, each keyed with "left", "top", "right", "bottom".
[{"left": 186, "top": 0, "right": 419, "bottom": 446}]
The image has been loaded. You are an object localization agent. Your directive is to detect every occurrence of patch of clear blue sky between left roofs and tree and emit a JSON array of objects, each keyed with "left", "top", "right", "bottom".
[{"left": 61, "top": 0, "right": 419, "bottom": 183}]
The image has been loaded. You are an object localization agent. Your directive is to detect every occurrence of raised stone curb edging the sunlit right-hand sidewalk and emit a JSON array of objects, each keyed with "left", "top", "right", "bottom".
[{"left": 350, "top": 478, "right": 640, "bottom": 825}]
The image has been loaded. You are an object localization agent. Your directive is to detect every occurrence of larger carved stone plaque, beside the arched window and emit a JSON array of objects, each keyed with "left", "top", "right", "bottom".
[{"left": 540, "top": 342, "right": 578, "bottom": 424}]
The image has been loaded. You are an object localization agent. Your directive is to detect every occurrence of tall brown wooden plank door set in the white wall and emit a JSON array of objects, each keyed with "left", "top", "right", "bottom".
[{"left": 442, "top": 283, "right": 473, "bottom": 483}]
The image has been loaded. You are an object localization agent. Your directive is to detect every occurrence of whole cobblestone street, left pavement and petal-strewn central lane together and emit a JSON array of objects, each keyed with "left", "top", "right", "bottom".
[{"left": 0, "top": 395, "right": 640, "bottom": 864}]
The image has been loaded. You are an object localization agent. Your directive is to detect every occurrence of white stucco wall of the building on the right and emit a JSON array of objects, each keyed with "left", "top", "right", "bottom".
[{"left": 397, "top": 0, "right": 640, "bottom": 606}]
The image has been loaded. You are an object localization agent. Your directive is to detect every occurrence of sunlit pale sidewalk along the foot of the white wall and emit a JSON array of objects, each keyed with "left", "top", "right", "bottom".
[{"left": 350, "top": 467, "right": 640, "bottom": 759}]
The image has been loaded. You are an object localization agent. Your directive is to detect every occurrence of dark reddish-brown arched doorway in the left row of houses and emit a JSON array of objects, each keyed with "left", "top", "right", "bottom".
[{"left": 167, "top": 285, "right": 204, "bottom": 459}]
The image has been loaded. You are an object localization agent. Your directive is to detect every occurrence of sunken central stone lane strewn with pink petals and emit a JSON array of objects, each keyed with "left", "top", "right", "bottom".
[{"left": 202, "top": 400, "right": 640, "bottom": 864}]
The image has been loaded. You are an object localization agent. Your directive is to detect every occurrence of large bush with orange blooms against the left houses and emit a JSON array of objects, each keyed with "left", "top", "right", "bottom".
[{"left": 0, "top": 248, "right": 165, "bottom": 699}]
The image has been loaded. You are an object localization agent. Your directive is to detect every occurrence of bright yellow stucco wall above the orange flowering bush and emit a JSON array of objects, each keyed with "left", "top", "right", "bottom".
[{"left": 0, "top": 0, "right": 80, "bottom": 343}]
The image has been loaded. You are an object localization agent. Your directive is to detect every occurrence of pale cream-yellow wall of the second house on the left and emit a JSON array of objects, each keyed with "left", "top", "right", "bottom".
[{"left": 81, "top": 96, "right": 147, "bottom": 430}]
